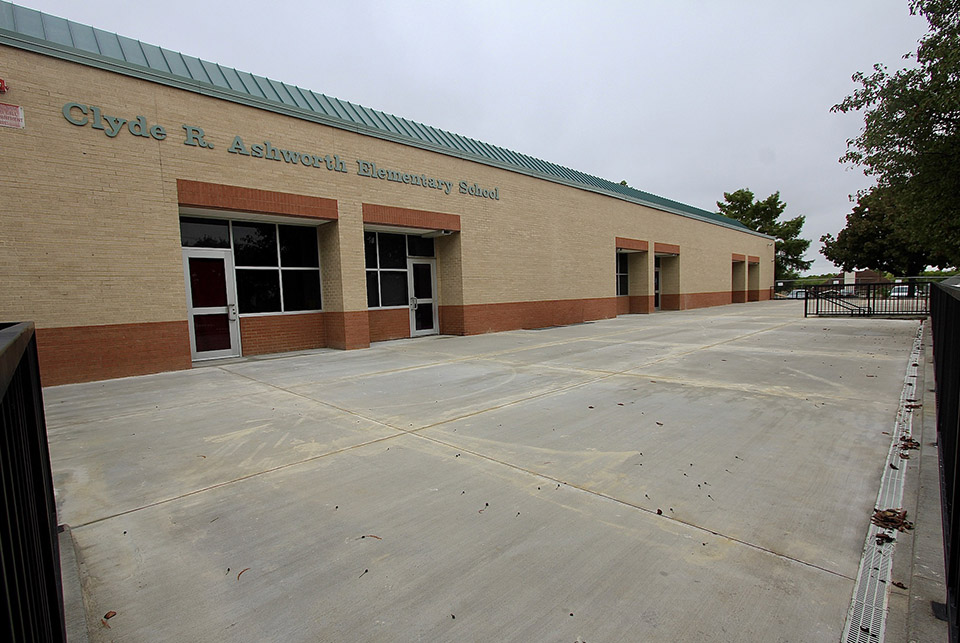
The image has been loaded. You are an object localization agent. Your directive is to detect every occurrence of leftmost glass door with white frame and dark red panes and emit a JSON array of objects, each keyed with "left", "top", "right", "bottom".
[{"left": 183, "top": 248, "right": 240, "bottom": 360}]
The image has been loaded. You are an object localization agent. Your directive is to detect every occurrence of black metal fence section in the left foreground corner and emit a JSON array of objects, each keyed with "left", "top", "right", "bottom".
[{"left": 0, "top": 323, "right": 66, "bottom": 641}]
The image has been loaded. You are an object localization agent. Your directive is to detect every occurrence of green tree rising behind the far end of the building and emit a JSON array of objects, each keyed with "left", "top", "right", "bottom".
[{"left": 717, "top": 188, "right": 813, "bottom": 279}]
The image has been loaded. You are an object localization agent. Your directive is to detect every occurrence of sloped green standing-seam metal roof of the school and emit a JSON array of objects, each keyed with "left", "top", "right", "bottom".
[{"left": 0, "top": 0, "right": 766, "bottom": 236}]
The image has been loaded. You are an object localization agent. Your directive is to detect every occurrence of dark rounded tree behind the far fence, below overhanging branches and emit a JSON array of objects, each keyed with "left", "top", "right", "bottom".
[{"left": 820, "top": 187, "right": 941, "bottom": 277}]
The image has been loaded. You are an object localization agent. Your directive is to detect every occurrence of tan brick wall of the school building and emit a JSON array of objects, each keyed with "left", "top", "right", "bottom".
[{"left": 0, "top": 47, "right": 773, "bottom": 346}]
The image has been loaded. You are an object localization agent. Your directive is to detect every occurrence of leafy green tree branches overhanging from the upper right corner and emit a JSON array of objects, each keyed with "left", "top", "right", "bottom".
[{"left": 832, "top": 0, "right": 960, "bottom": 267}]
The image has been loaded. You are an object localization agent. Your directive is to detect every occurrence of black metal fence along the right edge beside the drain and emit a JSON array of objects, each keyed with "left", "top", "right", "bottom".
[{"left": 930, "top": 277, "right": 960, "bottom": 641}]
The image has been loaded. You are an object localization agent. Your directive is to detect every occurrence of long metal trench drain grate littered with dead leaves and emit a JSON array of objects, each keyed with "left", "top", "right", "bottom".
[{"left": 841, "top": 322, "right": 925, "bottom": 643}]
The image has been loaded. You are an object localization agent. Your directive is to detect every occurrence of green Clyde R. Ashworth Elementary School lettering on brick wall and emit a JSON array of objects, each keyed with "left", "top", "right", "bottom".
[{"left": 62, "top": 102, "right": 500, "bottom": 201}]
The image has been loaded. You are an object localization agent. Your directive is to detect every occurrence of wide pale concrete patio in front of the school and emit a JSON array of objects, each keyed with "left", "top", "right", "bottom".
[{"left": 44, "top": 301, "right": 917, "bottom": 643}]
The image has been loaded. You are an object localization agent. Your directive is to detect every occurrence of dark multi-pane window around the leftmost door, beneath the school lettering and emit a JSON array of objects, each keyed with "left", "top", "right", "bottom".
[{"left": 180, "top": 217, "right": 321, "bottom": 314}]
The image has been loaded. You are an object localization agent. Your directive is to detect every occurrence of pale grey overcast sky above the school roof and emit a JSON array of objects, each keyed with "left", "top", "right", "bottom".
[{"left": 18, "top": 0, "right": 926, "bottom": 273}]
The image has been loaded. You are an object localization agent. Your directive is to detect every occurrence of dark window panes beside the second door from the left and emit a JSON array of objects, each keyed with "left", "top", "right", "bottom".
[{"left": 363, "top": 230, "right": 434, "bottom": 308}]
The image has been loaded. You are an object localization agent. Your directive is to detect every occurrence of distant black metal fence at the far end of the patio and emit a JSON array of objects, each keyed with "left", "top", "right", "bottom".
[{"left": 804, "top": 281, "right": 932, "bottom": 318}]
